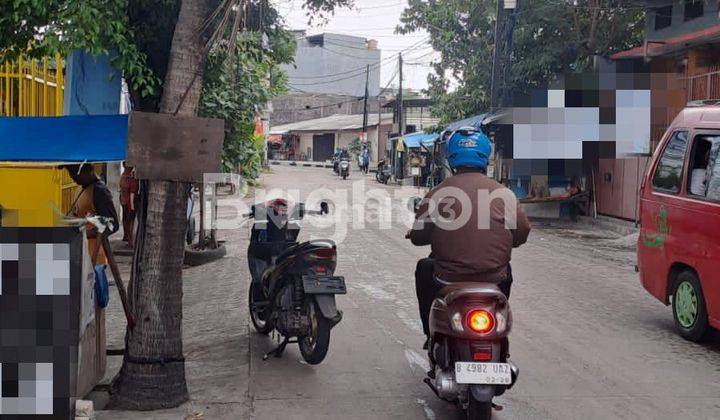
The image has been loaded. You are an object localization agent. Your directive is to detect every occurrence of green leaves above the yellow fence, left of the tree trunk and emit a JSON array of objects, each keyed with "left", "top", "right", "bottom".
[{"left": 0, "top": 0, "right": 159, "bottom": 95}]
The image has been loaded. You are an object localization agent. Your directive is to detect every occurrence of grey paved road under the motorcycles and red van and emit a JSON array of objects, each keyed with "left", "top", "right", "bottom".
[{"left": 101, "top": 166, "right": 720, "bottom": 420}]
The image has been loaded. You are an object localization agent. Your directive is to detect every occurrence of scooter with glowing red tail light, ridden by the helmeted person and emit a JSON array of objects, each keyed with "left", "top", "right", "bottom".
[{"left": 408, "top": 197, "right": 519, "bottom": 420}]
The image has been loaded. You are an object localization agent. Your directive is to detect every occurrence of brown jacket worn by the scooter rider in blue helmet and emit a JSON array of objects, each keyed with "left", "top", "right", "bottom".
[{"left": 410, "top": 172, "right": 530, "bottom": 283}]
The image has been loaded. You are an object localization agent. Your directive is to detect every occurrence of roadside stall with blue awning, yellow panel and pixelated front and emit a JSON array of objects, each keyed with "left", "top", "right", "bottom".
[{"left": 0, "top": 115, "right": 128, "bottom": 418}]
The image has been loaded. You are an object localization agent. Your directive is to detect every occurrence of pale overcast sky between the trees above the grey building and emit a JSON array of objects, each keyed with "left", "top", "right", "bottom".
[{"left": 274, "top": 0, "right": 437, "bottom": 89}]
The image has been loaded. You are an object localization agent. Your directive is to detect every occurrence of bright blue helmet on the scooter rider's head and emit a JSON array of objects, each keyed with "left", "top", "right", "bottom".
[{"left": 445, "top": 128, "right": 491, "bottom": 170}]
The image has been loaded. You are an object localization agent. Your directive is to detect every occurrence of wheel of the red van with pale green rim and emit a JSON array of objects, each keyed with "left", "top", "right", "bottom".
[{"left": 672, "top": 270, "right": 709, "bottom": 342}]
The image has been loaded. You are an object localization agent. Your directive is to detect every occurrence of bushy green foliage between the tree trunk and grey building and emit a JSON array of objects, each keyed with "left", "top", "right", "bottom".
[{"left": 199, "top": 28, "right": 295, "bottom": 180}]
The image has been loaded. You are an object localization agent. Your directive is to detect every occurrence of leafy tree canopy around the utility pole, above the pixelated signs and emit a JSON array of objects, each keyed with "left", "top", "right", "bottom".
[{"left": 398, "top": 0, "right": 645, "bottom": 123}]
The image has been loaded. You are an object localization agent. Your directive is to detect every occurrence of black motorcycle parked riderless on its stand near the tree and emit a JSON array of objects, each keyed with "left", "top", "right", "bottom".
[{"left": 245, "top": 199, "right": 347, "bottom": 365}]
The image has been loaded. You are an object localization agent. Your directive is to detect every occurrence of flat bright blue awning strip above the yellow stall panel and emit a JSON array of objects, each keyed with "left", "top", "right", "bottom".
[{"left": 0, "top": 115, "right": 128, "bottom": 162}]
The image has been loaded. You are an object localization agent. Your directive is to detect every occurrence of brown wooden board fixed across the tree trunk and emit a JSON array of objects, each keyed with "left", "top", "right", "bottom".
[{"left": 127, "top": 112, "right": 225, "bottom": 182}]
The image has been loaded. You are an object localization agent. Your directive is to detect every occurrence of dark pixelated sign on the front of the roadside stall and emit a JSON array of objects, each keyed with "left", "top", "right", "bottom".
[{"left": 0, "top": 228, "right": 83, "bottom": 419}]
